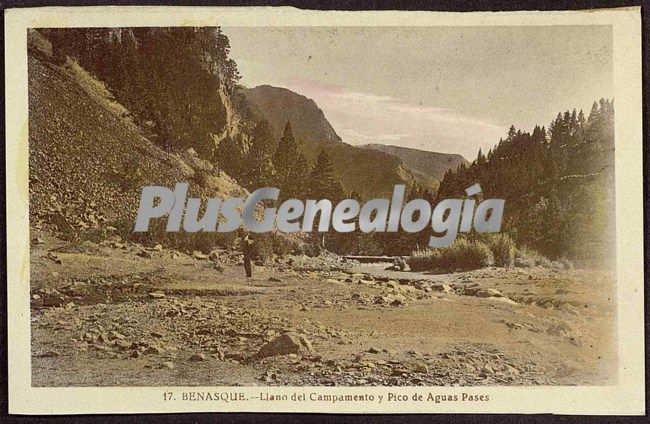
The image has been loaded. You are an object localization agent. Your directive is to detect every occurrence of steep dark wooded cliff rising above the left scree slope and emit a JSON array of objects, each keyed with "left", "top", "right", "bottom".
[{"left": 41, "top": 27, "right": 239, "bottom": 157}]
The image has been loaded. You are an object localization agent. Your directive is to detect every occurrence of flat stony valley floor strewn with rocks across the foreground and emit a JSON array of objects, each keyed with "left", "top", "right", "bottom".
[{"left": 31, "top": 233, "right": 617, "bottom": 386}]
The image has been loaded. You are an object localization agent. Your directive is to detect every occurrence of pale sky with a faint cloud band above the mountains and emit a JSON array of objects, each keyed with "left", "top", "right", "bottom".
[{"left": 223, "top": 26, "right": 613, "bottom": 161}]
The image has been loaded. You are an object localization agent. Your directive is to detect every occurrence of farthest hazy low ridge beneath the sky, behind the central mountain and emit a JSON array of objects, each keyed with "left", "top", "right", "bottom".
[{"left": 361, "top": 144, "right": 469, "bottom": 180}]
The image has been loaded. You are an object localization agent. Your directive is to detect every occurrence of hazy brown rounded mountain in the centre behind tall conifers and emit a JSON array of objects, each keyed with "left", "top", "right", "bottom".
[{"left": 243, "top": 85, "right": 438, "bottom": 198}]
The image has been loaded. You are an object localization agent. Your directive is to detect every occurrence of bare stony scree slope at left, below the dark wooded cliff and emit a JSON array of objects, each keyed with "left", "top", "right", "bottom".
[{"left": 29, "top": 33, "right": 246, "bottom": 245}]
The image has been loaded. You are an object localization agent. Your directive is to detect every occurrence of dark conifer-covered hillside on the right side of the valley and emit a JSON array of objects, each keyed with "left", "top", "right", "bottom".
[{"left": 436, "top": 99, "right": 615, "bottom": 264}]
